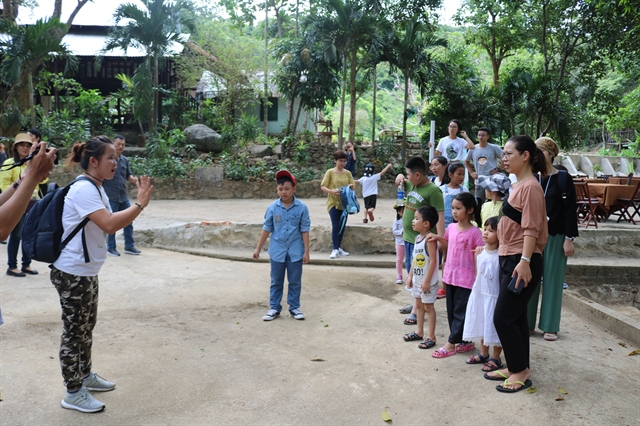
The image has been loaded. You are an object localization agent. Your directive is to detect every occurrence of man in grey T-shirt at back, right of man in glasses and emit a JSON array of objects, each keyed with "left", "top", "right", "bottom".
[{"left": 464, "top": 127, "right": 502, "bottom": 206}]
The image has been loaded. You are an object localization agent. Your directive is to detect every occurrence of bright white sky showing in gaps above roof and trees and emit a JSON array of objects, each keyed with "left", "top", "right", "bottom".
[{"left": 18, "top": 0, "right": 461, "bottom": 25}]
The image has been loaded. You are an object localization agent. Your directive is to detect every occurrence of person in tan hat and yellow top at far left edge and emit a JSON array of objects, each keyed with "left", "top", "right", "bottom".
[{"left": 0, "top": 133, "right": 49, "bottom": 278}]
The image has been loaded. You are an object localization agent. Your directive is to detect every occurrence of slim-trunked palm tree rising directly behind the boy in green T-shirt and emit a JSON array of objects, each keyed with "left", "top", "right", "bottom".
[{"left": 384, "top": 17, "right": 446, "bottom": 163}]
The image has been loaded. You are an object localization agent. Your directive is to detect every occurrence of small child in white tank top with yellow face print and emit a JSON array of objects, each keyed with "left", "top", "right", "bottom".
[{"left": 404, "top": 206, "right": 438, "bottom": 349}]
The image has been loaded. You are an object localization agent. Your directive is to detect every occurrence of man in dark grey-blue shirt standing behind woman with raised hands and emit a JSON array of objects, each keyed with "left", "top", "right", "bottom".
[{"left": 102, "top": 135, "right": 140, "bottom": 256}]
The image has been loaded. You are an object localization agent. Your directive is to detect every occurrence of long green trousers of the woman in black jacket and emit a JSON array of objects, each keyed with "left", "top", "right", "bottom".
[{"left": 527, "top": 235, "right": 567, "bottom": 333}]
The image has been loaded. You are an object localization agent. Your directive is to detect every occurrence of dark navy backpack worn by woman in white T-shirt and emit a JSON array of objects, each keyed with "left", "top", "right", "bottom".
[{"left": 22, "top": 176, "right": 102, "bottom": 263}]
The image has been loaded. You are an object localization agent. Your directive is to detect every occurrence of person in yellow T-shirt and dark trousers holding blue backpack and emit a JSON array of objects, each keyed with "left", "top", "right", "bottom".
[{"left": 320, "top": 150, "right": 354, "bottom": 259}]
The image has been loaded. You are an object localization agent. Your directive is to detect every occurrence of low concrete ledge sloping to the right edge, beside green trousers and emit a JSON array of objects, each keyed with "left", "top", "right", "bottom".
[{"left": 563, "top": 290, "right": 640, "bottom": 346}]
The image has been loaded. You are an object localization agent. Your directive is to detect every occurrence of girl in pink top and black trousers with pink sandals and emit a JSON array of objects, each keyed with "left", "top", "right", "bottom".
[{"left": 429, "top": 192, "right": 484, "bottom": 358}]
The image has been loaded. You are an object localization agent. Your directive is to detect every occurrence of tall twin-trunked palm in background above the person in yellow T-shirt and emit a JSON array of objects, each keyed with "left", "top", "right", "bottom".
[{"left": 309, "top": 0, "right": 388, "bottom": 145}]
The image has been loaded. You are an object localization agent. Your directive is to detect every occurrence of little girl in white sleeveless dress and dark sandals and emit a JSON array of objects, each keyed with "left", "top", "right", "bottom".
[{"left": 462, "top": 216, "right": 502, "bottom": 371}]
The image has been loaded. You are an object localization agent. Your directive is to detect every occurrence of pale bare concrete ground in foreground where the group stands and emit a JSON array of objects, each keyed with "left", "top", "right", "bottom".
[{"left": 0, "top": 248, "right": 640, "bottom": 425}]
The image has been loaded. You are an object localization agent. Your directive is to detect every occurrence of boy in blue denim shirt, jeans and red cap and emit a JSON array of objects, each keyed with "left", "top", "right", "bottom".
[{"left": 253, "top": 170, "right": 311, "bottom": 321}]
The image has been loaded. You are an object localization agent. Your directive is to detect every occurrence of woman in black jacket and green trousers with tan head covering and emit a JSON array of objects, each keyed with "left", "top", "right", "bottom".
[{"left": 527, "top": 137, "right": 578, "bottom": 341}]
